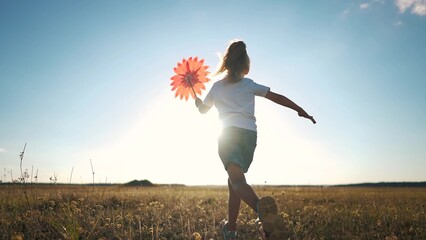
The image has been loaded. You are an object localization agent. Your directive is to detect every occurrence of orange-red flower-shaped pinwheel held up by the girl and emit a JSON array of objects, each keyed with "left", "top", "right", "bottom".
[{"left": 170, "top": 57, "right": 210, "bottom": 100}]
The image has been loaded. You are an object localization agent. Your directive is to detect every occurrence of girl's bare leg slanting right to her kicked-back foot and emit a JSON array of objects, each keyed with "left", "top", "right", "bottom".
[{"left": 227, "top": 163, "right": 259, "bottom": 212}]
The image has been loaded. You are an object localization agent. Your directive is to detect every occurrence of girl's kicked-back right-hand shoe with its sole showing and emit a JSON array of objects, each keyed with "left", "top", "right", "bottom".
[{"left": 257, "top": 197, "right": 292, "bottom": 240}]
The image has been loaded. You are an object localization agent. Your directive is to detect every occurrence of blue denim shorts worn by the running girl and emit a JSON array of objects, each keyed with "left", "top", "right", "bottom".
[{"left": 218, "top": 127, "right": 257, "bottom": 173}]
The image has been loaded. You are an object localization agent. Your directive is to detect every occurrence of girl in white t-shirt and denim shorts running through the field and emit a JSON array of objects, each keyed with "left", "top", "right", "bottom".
[{"left": 195, "top": 41, "right": 315, "bottom": 239}]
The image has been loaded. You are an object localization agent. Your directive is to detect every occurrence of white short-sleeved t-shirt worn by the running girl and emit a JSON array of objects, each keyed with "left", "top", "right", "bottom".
[{"left": 204, "top": 78, "right": 269, "bottom": 131}]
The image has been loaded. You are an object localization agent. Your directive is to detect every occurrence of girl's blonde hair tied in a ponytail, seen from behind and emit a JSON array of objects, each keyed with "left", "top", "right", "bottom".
[{"left": 215, "top": 40, "right": 250, "bottom": 82}]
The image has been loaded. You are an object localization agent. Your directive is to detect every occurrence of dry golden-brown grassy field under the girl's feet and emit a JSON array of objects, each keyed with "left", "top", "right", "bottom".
[{"left": 0, "top": 185, "right": 426, "bottom": 240}]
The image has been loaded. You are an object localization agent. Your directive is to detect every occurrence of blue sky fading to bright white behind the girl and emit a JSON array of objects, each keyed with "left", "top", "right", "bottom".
[{"left": 0, "top": 0, "right": 426, "bottom": 185}]
